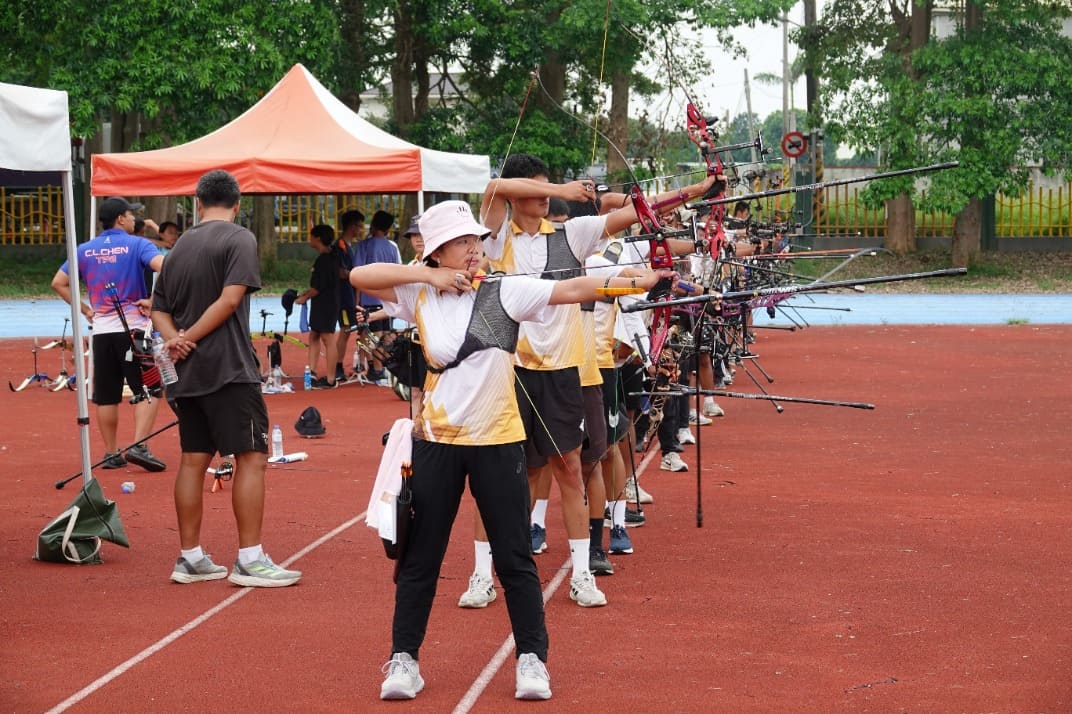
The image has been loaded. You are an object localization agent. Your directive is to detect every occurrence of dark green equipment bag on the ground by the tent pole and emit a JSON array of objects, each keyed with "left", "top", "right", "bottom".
[{"left": 33, "top": 478, "right": 130, "bottom": 565}]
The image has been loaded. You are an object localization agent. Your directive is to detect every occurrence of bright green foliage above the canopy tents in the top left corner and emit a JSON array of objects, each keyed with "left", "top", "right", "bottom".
[{"left": 0, "top": 0, "right": 338, "bottom": 148}]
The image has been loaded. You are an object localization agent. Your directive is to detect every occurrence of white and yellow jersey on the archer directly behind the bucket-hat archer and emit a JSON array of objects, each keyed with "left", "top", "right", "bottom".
[{"left": 483, "top": 215, "right": 607, "bottom": 370}]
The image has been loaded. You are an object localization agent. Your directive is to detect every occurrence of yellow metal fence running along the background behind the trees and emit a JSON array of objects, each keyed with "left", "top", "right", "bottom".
[{"left": 6, "top": 182, "right": 1072, "bottom": 247}]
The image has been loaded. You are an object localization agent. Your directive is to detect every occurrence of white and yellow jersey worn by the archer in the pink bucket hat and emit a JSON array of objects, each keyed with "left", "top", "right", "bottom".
[{"left": 384, "top": 276, "right": 554, "bottom": 446}]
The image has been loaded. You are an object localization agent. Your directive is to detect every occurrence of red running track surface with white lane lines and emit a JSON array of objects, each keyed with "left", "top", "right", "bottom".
[{"left": 0, "top": 325, "right": 1072, "bottom": 713}]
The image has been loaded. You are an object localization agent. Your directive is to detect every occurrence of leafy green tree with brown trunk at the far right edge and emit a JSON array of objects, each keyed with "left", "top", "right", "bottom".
[{"left": 914, "top": 0, "right": 1072, "bottom": 266}]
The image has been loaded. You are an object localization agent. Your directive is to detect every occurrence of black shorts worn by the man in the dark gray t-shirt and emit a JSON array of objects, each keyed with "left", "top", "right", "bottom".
[{"left": 175, "top": 384, "right": 268, "bottom": 455}]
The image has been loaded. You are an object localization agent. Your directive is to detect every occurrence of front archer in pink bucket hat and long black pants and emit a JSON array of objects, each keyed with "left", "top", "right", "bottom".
[{"left": 351, "top": 200, "right": 673, "bottom": 699}]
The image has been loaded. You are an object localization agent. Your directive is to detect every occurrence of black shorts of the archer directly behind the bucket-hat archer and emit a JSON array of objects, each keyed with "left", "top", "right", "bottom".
[{"left": 513, "top": 367, "right": 584, "bottom": 468}]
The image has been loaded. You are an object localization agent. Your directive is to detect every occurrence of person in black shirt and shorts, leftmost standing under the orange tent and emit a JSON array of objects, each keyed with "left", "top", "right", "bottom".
[{"left": 295, "top": 224, "right": 339, "bottom": 389}]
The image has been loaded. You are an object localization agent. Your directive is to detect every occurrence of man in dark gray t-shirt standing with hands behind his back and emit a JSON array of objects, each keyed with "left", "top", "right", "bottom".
[{"left": 152, "top": 169, "right": 301, "bottom": 587}]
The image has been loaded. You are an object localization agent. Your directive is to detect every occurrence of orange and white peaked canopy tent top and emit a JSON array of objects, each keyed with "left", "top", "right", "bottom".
[{"left": 90, "top": 64, "right": 491, "bottom": 196}]
